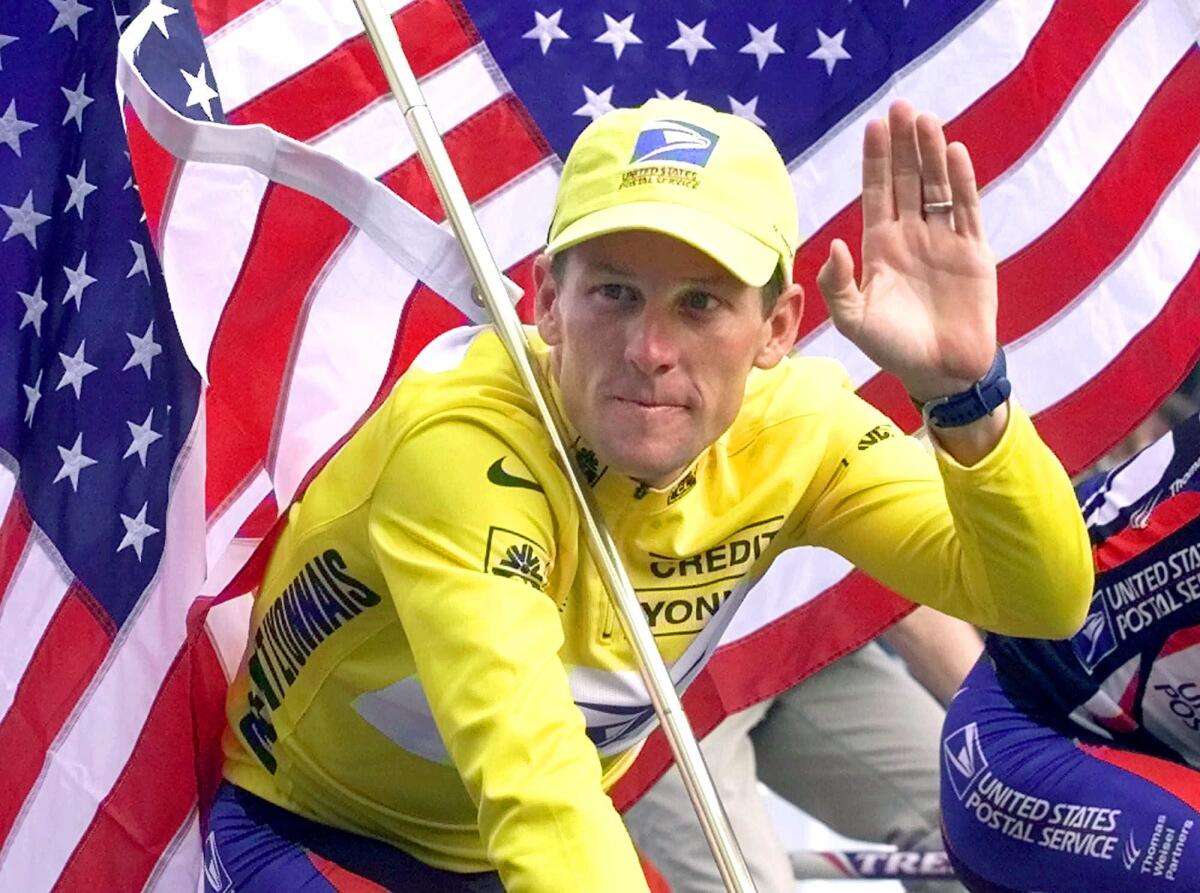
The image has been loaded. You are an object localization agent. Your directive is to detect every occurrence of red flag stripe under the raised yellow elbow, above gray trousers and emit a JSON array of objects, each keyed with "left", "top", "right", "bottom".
[{"left": 611, "top": 570, "right": 913, "bottom": 810}]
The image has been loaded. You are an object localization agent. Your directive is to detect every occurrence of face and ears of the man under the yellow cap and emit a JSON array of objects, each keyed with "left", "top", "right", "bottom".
[{"left": 535, "top": 232, "right": 800, "bottom": 487}]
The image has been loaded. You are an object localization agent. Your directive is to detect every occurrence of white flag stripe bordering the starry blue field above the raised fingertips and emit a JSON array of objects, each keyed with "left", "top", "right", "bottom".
[{"left": 790, "top": 0, "right": 1054, "bottom": 239}]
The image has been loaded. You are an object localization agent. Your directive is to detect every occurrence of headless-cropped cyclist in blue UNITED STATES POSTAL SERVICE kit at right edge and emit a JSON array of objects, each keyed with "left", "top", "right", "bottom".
[{"left": 942, "top": 415, "right": 1200, "bottom": 893}]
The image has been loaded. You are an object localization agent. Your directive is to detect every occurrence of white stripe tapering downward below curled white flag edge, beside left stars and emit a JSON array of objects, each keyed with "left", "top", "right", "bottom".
[{"left": 162, "top": 161, "right": 268, "bottom": 379}]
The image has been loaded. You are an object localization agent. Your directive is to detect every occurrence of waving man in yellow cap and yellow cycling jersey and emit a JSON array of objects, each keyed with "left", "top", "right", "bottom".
[{"left": 210, "top": 101, "right": 1091, "bottom": 891}]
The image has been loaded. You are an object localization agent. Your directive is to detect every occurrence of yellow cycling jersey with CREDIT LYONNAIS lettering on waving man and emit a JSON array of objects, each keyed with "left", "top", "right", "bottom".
[{"left": 223, "top": 328, "right": 1092, "bottom": 891}]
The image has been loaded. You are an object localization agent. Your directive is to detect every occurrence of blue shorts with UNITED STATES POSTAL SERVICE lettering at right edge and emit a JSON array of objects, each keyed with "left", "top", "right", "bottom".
[{"left": 941, "top": 655, "right": 1200, "bottom": 893}]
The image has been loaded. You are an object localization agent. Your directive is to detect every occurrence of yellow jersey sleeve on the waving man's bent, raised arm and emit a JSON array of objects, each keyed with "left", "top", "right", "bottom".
[{"left": 800, "top": 379, "right": 1093, "bottom": 639}]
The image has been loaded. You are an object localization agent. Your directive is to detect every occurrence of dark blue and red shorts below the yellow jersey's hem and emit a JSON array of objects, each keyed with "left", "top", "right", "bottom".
[{"left": 204, "top": 781, "right": 504, "bottom": 893}]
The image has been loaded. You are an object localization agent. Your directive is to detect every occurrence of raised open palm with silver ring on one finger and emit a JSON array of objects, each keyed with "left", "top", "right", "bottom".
[{"left": 817, "top": 102, "right": 996, "bottom": 401}]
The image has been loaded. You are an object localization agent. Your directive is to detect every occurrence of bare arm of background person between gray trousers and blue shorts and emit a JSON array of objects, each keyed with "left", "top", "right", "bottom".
[{"left": 881, "top": 605, "right": 983, "bottom": 707}]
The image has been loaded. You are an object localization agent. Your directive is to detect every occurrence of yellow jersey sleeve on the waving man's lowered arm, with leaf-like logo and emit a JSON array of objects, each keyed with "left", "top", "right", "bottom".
[{"left": 370, "top": 420, "right": 646, "bottom": 893}]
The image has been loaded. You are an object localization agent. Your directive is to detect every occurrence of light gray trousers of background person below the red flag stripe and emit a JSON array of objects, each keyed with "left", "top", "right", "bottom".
[{"left": 625, "top": 643, "right": 964, "bottom": 893}]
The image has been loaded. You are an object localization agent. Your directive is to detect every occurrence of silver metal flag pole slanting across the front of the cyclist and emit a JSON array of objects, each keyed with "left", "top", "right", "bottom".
[{"left": 354, "top": 0, "right": 754, "bottom": 893}]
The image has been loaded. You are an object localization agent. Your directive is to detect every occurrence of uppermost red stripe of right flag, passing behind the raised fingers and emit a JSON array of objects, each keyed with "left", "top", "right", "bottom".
[{"left": 796, "top": 0, "right": 1136, "bottom": 336}]
